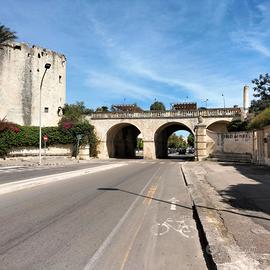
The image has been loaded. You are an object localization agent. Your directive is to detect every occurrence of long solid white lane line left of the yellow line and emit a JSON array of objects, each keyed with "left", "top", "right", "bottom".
[{"left": 83, "top": 168, "right": 160, "bottom": 270}]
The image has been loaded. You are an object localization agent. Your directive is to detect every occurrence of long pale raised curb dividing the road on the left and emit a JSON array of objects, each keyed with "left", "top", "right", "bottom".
[{"left": 0, "top": 163, "right": 128, "bottom": 195}]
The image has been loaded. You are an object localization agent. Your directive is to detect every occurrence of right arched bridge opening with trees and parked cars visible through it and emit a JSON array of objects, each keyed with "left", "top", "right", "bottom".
[{"left": 155, "top": 122, "right": 195, "bottom": 158}]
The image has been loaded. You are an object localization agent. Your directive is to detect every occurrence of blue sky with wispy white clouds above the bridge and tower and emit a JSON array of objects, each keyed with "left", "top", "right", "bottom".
[{"left": 0, "top": 0, "right": 270, "bottom": 109}]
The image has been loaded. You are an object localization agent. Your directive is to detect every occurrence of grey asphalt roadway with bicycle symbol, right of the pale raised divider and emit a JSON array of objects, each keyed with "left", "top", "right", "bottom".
[{"left": 0, "top": 161, "right": 207, "bottom": 270}]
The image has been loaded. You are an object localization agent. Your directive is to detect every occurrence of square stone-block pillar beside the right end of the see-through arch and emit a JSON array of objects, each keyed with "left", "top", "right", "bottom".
[{"left": 195, "top": 124, "right": 207, "bottom": 161}]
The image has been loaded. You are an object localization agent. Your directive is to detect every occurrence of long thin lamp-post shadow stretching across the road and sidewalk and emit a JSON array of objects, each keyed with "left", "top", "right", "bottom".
[{"left": 97, "top": 187, "right": 270, "bottom": 221}]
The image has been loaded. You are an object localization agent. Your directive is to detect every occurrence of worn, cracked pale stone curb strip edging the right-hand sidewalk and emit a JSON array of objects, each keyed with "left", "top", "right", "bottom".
[{"left": 181, "top": 165, "right": 260, "bottom": 270}]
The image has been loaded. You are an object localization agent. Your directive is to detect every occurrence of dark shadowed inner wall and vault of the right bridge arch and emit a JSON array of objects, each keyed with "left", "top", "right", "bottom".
[{"left": 154, "top": 122, "right": 194, "bottom": 158}]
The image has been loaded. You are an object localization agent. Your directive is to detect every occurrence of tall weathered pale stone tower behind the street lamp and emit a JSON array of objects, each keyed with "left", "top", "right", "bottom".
[{"left": 0, "top": 43, "right": 66, "bottom": 126}]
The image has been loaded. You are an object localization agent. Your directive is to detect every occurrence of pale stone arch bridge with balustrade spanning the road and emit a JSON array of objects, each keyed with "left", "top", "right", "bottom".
[{"left": 88, "top": 108, "right": 243, "bottom": 160}]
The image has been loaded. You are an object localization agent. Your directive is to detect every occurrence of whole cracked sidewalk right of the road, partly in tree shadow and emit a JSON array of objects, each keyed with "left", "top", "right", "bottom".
[{"left": 183, "top": 162, "right": 270, "bottom": 270}]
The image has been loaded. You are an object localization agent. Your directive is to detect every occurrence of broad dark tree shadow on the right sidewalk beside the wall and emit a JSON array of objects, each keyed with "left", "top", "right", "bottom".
[{"left": 217, "top": 163, "right": 270, "bottom": 214}]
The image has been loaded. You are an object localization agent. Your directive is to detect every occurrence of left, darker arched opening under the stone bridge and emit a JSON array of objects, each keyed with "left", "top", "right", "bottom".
[{"left": 107, "top": 123, "right": 143, "bottom": 158}]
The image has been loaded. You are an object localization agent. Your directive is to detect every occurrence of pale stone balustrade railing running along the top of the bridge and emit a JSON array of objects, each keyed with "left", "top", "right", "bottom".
[{"left": 90, "top": 108, "right": 242, "bottom": 119}]
